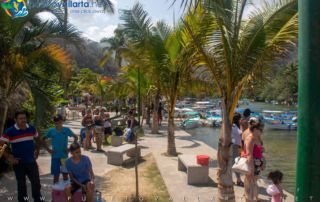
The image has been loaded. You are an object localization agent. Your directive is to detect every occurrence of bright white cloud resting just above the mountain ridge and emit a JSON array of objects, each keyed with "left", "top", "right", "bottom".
[{"left": 83, "top": 25, "right": 117, "bottom": 42}]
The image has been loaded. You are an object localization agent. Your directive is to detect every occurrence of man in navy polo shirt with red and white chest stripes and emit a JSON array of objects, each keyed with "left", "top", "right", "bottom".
[{"left": 0, "top": 111, "right": 44, "bottom": 202}]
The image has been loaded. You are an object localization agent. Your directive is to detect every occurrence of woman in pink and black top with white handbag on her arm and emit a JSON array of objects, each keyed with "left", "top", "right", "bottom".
[{"left": 241, "top": 118, "right": 265, "bottom": 202}]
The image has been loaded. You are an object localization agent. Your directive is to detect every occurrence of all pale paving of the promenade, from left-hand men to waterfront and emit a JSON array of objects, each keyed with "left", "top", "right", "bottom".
[{"left": 0, "top": 116, "right": 294, "bottom": 202}]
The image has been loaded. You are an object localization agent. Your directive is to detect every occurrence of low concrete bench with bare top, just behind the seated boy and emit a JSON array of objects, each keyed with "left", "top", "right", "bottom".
[{"left": 107, "top": 144, "right": 141, "bottom": 166}]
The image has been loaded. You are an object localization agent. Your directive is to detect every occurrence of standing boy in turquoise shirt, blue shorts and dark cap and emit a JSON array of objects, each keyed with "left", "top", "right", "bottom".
[{"left": 44, "top": 115, "right": 78, "bottom": 184}]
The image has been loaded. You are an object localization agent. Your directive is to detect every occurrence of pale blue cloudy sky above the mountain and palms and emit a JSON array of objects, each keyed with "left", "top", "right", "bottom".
[{"left": 43, "top": 0, "right": 260, "bottom": 42}]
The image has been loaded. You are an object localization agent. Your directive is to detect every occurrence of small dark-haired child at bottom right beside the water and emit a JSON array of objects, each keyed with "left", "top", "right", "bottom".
[{"left": 267, "top": 170, "right": 286, "bottom": 202}]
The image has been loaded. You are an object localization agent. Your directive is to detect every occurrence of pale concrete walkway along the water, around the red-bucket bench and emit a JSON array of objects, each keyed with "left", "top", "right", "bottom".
[{"left": 140, "top": 125, "right": 294, "bottom": 202}]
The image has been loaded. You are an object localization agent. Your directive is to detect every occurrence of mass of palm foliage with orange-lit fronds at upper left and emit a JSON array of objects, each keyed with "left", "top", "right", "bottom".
[{"left": 0, "top": 0, "right": 81, "bottom": 133}]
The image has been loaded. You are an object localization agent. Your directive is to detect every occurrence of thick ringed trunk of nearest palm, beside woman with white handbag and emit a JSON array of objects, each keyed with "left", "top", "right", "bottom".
[{"left": 217, "top": 99, "right": 235, "bottom": 202}]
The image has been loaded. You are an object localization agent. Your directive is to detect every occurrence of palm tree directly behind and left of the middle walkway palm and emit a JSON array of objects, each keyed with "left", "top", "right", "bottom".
[{"left": 120, "top": 4, "right": 162, "bottom": 134}]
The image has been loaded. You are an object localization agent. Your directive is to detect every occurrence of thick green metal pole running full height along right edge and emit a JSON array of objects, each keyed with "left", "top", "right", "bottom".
[{"left": 296, "top": 0, "right": 320, "bottom": 202}]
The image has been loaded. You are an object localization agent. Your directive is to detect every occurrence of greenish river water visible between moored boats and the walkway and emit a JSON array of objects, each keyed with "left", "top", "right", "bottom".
[{"left": 187, "top": 103, "right": 297, "bottom": 193}]
